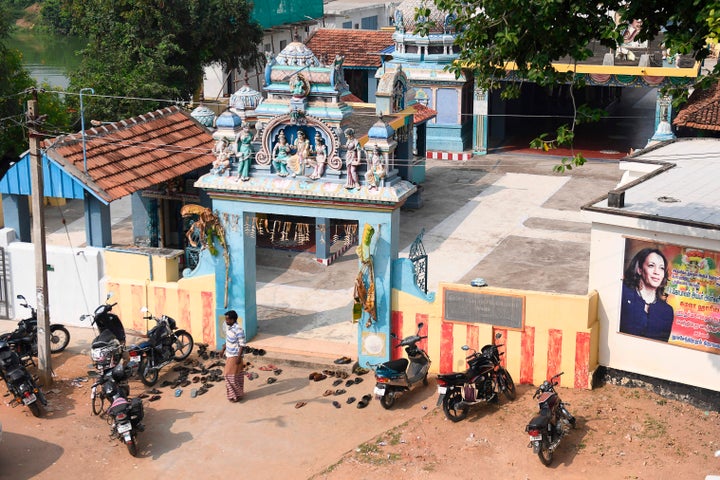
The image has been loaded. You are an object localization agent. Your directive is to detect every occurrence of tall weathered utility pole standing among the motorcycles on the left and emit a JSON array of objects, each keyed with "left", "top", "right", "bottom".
[{"left": 27, "top": 94, "right": 52, "bottom": 388}]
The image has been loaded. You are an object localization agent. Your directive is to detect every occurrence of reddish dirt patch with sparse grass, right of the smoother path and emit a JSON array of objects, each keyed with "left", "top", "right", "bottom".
[{"left": 313, "top": 385, "right": 720, "bottom": 480}]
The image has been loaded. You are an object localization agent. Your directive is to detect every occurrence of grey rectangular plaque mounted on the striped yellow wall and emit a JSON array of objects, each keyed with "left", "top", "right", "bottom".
[{"left": 444, "top": 289, "right": 525, "bottom": 329}]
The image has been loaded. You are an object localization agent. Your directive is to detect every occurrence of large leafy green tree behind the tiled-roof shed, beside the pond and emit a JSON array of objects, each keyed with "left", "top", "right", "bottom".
[{"left": 69, "top": 0, "right": 263, "bottom": 120}]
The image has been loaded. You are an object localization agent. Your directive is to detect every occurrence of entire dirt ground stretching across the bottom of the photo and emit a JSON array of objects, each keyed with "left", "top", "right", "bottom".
[{"left": 0, "top": 344, "right": 720, "bottom": 480}]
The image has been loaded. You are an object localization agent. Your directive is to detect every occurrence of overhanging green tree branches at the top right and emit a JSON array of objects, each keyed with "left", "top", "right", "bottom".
[{"left": 416, "top": 0, "right": 720, "bottom": 170}]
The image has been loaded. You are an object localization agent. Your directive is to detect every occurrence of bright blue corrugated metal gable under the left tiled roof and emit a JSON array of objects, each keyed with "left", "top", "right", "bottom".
[{"left": 0, "top": 151, "right": 104, "bottom": 205}]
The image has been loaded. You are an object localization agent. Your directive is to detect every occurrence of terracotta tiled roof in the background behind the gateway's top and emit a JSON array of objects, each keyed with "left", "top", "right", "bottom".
[{"left": 305, "top": 28, "right": 394, "bottom": 68}]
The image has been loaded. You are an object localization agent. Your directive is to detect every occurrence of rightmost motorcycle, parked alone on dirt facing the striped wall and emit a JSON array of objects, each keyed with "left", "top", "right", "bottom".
[{"left": 525, "top": 372, "right": 575, "bottom": 467}]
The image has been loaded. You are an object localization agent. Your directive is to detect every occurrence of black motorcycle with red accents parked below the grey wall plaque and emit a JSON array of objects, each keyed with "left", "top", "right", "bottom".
[{"left": 437, "top": 334, "right": 516, "bottom": 422}]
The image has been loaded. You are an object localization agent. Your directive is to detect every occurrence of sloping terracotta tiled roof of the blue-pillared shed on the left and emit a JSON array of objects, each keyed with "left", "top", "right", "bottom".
[{"left": 43, "top": 107, "right": 214, "bottom": 202}]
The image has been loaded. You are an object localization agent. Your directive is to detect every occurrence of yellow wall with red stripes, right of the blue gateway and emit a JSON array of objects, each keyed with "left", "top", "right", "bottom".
[{"left": 391, "top": 283, "right": 599, "bottom": 389}]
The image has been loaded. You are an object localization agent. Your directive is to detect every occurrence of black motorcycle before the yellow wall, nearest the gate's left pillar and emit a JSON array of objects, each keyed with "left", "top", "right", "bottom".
[{"left": 130, "top": 307, "right": 194, "bottom": 387}]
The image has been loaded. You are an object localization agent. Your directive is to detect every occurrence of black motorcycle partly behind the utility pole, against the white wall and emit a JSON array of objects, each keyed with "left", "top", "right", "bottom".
[{"left": 0, "top": 295, "right": 70, "bottom": 365}]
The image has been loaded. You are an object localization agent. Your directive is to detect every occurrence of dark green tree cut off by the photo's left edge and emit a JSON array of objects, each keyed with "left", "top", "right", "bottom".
[{"left": 0, "top": 5, "right": 35, "bottom": 178}]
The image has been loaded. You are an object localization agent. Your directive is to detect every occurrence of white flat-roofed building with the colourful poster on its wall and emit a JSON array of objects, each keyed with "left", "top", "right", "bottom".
[{"left": 583, "top": 138, "right": 720, "bottom": 391}]
